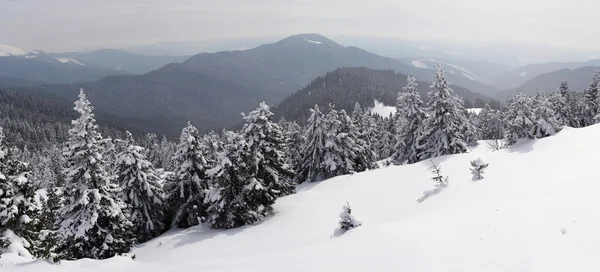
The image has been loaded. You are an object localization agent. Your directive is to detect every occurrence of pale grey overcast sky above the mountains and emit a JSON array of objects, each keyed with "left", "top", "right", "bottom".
[{"left": 0, "top": 0, "right": 600, "bottom": 51}]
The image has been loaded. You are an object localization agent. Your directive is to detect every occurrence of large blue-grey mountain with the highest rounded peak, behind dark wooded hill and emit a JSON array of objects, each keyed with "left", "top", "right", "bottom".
[{"left": 14, "top": 34, "right": 494, "bottom": 135}]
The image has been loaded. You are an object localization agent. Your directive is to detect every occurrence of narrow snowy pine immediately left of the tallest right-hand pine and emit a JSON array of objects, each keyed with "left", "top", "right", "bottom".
[{"left": 392, "top": 76, "right": 427, "bottom": 164}]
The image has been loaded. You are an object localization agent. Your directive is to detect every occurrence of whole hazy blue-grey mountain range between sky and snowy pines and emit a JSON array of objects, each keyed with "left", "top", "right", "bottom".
[{"left": 14, "top": 34, "right": 600, "bottom": 136}]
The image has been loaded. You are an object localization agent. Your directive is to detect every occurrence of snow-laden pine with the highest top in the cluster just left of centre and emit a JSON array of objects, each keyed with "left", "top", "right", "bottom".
[{"left": 241, "top": 101, "right": 296, "bottom": 197}]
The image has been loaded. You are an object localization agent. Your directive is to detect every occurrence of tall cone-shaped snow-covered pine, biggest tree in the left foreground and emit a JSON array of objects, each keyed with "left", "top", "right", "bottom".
[{"left": 57, "top": 90, "right": 135, "bottom": 259}]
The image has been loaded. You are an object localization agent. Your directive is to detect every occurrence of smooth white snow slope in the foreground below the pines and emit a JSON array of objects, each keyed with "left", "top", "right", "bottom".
[{"left": 5, "top": 125, "right": 600, "bottom": 272}]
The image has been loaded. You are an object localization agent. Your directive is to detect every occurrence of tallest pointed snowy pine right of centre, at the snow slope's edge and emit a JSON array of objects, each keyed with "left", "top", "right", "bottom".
[{"left": 417, "top": 65, "right": 468, "bottom": 160}]
